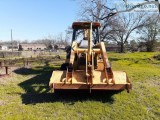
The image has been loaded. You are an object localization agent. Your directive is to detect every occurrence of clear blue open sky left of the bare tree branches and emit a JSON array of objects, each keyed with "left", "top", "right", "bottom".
[{"left": 0, "top": 0, "right": 78, "bottom": 41}]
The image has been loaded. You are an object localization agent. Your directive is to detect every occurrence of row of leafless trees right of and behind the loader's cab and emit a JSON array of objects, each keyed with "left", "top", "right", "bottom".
[{"left": 74, "top": 0, "right": 160, "bottom": 52}]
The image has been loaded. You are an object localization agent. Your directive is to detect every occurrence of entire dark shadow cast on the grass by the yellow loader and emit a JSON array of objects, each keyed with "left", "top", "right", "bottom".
[{"left": 14, "top": 63, "right": 118, "bottom": 104}]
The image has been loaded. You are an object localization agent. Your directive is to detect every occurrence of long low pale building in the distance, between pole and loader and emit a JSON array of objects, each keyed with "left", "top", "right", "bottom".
[{"left": 19, "top": 43, "right": 46, "bottom": 51}]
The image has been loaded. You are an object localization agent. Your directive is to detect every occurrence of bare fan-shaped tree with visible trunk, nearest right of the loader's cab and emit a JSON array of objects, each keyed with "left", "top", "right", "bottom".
[{"left": 108, "top": 13, "right": 149, "bottom": 52}]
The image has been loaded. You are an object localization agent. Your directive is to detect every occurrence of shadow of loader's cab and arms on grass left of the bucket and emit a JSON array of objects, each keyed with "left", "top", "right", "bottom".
[{"left": 14, "top": 66, "right": 54, "bottom": 94}]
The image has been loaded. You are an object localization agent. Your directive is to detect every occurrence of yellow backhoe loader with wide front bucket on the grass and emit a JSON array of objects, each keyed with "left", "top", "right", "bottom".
[{"left": 49, "top": 22, "right": 132, "bottom": 92}]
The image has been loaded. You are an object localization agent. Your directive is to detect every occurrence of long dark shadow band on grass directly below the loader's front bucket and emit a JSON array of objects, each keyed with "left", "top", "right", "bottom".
[{"left": 22, "top": 91, "right": 118, "bottom": 104}]
